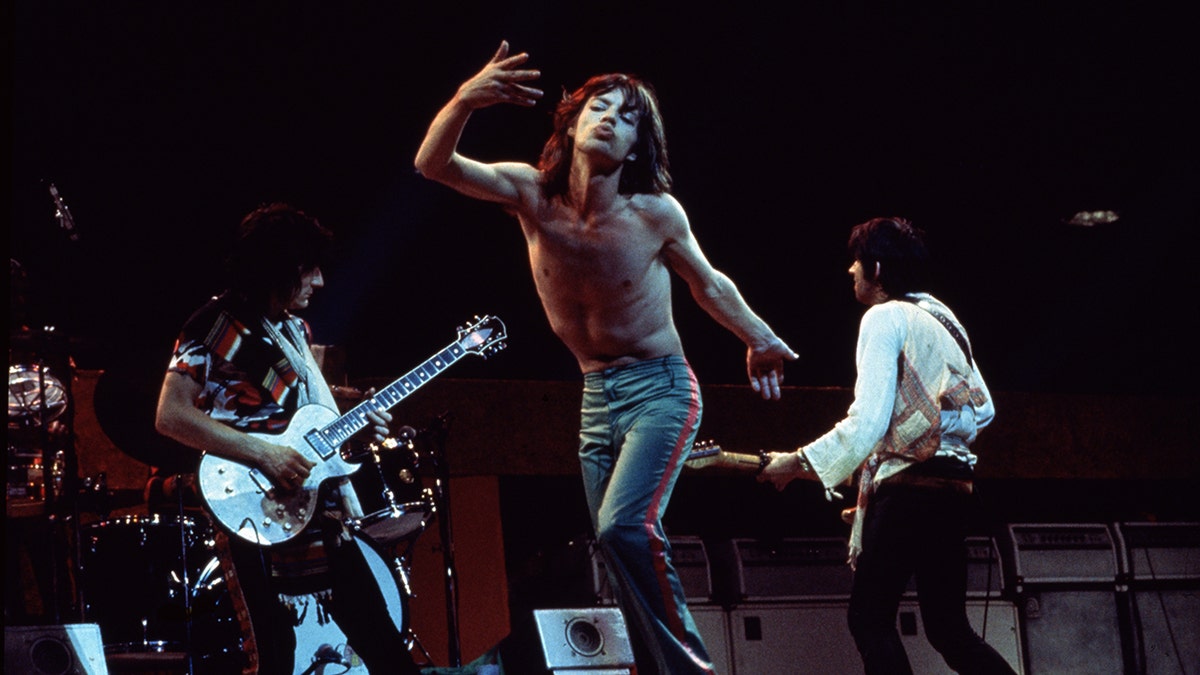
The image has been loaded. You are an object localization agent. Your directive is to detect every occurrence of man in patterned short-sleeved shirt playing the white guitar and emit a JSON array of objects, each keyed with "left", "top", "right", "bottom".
[{"left": 156, "top": 203, "right": 418, "bottom": 675}]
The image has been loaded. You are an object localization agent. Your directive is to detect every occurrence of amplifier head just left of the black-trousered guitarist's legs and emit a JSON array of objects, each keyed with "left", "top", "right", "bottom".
[{"left": 732, "top": 537, "right": 852, "bottom": 602}]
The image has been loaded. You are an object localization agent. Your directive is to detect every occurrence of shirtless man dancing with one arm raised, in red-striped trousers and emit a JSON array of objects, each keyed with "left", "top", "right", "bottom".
[{"left": 415, "top": 42, "right": 797, "bottom": 675}]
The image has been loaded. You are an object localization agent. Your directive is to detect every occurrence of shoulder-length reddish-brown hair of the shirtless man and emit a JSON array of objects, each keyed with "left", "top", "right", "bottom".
[{"left": 538, "top": 73, "right": 671, "bottom": 197}]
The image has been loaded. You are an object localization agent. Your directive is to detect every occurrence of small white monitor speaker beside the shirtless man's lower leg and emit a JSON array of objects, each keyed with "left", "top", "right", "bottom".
[{"left": 533, "top": 607, "right": 634, "bottom": 675}]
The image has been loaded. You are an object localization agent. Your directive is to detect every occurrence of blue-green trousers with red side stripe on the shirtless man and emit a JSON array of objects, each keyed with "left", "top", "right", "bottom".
[{"left": 580, "top": 356, "right": 714, "bottom": 675}]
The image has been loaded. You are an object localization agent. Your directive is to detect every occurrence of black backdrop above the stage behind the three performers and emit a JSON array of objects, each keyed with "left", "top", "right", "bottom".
[{"left": 8, "top": 0, "right": 1200, "bottom": 394}]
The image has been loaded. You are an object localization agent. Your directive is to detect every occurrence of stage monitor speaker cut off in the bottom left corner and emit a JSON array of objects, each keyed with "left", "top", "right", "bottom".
[{"left": 4, "top": 623, "right": 108, "bottom": 675}]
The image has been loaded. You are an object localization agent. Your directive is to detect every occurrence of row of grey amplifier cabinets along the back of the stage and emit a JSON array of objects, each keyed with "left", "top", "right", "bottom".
[{"left": 564, "top": 522, "right": 1200, "bottom": 675}]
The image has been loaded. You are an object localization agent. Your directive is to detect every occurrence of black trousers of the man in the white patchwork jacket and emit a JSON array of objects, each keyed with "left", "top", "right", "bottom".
[{"left": 848, "top": 484, "right": 1013, "bottom": 675}]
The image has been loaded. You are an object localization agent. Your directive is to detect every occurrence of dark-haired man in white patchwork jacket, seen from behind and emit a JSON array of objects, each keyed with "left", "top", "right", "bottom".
[{"left": 758, "top": 217, "right": 1013, "bottom": 675}]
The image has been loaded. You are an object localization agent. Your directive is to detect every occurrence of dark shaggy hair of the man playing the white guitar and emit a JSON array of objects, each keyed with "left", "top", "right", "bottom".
[{"left": 226, "top": 202, "right": 332, "bottom": 307}]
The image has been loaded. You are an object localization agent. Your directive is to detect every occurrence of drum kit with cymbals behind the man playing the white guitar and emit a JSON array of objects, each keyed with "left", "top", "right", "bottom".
[{"left": 5, "top": 190, "right": 452, "bottom": 675}]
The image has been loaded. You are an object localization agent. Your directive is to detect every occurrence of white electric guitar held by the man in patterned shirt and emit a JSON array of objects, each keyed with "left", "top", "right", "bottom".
[{"left": 197, "top": 316, "right": 506, "bottom": 546}]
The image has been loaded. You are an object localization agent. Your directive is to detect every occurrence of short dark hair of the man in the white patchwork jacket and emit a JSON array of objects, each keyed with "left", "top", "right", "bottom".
[{"left": 848, "top": 217, "right": 930, "bottom": 297}]
